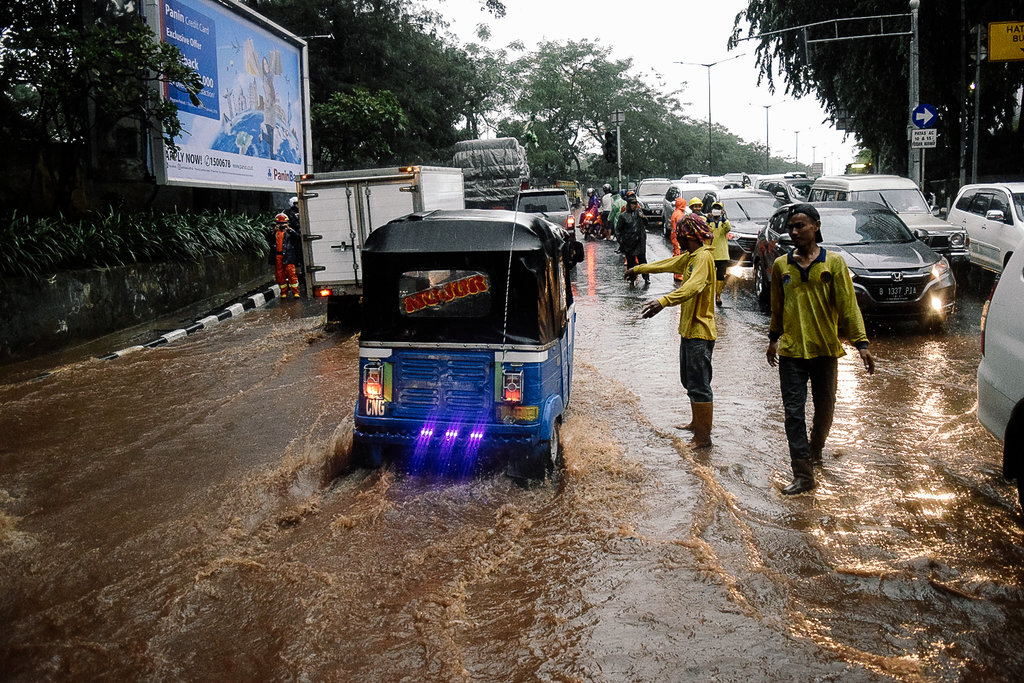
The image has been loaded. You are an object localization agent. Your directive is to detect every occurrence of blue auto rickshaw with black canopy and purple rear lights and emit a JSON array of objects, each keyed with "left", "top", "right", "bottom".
[{"left": 352, "top": 210, "right": 583, "bottom": 480}]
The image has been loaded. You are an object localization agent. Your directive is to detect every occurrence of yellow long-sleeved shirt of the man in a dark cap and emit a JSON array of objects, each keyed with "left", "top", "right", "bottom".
[{"left": 768, "top": 249, "right": 867, "bottom": 358}]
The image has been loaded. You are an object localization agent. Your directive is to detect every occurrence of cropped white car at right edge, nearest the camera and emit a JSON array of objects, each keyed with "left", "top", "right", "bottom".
[{"left": 978, "top": 243, "right": 1024, "bottom": 505}]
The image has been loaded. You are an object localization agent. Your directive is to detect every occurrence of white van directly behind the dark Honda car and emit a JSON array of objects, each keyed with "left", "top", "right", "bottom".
[{"left": 808, "top": 173, "right": 970, "bottom": 265}]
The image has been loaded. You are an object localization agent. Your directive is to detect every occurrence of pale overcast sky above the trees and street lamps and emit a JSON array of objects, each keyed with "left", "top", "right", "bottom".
[{"left": 424, "top": 0, "right": 856, "bottom": 173}]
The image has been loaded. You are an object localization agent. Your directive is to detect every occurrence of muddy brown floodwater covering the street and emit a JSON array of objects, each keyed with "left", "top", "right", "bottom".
[{"left": 0, "top": 232, "right": 1024, "bottom": 681}]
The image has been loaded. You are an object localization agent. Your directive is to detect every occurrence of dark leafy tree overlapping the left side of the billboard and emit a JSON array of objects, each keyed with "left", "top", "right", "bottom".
[{"left": 0, "top": 0, "right": 202, "bottom": 211}]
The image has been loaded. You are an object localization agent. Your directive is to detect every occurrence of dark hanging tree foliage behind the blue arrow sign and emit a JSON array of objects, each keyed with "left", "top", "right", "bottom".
[{"left": 733, "top": 0, "right": 1024, "bottom": 184}]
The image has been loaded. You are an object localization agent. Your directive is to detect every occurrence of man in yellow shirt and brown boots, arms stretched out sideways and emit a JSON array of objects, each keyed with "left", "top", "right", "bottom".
[{"left": 626, "top": 214, "right": 716, "bottom": 449}]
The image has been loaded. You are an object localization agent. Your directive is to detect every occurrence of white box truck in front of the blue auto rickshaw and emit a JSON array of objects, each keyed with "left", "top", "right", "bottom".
[{"left": 296, "top": 166, "right": 466, "bottom": 323}]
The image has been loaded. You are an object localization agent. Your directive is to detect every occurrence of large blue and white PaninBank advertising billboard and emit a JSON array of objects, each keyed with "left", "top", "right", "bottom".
[{"left": 147, "top": 0, "right": 310, "bottom": 191}]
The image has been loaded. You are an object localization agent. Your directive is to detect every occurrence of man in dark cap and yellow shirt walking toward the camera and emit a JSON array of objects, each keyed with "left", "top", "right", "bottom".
[{"left": 766, "top": 204, "right": 874, "bottom": 496}]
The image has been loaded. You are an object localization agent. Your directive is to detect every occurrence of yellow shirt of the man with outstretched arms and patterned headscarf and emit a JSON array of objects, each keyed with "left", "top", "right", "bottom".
[{"left": 633, "top": 245, "right": 717, "bottom": 341}]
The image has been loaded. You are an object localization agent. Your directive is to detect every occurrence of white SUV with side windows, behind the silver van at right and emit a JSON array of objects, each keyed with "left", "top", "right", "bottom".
[{"left": 947, "top": 182, "right": 1024, "bottom": 272}]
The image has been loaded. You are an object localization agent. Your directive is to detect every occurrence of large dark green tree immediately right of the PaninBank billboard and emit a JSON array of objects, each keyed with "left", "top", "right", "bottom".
[{"left": 251, "top": 0, "right": 504, "bottom": 167}]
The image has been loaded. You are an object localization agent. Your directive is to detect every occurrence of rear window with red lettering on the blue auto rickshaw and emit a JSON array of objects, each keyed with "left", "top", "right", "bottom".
[{"left": 398, "top": 269, "right": 492, "bottom": 317}]
